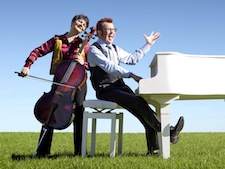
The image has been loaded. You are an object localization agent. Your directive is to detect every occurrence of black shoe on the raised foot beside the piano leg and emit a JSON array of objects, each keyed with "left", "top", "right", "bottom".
[{"left": 170, "top": 116, "right": 184, "bottom": 144}]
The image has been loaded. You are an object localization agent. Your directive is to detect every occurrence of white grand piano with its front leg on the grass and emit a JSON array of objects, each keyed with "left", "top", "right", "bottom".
[{"left": 137, "top": 52, "right": 225, "bottom": 158}]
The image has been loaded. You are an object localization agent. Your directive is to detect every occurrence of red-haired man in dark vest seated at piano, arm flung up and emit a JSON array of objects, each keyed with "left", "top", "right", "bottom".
[{"left": 87, "top": 18, "right": 184, "bottom": 154}]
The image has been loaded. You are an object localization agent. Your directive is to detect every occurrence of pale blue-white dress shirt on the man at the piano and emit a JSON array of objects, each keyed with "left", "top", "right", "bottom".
[{"left": 87, "top": 39, "right": 150, "bottom": 78}]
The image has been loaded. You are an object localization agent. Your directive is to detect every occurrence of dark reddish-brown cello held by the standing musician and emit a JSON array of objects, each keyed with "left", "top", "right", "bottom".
[{"left": 34, "top": 27, "right": 95, "bottom": 130}]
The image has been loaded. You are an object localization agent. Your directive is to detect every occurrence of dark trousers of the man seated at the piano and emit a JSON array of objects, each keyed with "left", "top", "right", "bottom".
[{"left": 97, "top": 84, "right": 161, "bottom": 151}]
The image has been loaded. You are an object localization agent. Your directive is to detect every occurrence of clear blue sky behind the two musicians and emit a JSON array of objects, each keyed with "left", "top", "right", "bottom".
[{"left": 0, "top": 0, "right": 225, "bottom": 132}]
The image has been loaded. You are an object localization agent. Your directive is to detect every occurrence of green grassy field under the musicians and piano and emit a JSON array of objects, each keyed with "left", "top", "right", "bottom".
[{"left": 0, "top": 132, "right": 225, "bottom": 169}]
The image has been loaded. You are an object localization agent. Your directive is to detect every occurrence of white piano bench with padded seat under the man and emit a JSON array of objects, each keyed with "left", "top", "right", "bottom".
[{"left": 81, "top": 100, "right": 123, "bottom": 157}]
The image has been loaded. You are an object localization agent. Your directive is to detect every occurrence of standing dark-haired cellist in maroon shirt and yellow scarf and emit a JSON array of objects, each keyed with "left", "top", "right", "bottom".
[{"left": 20, "top": 14, "right": 90, "bottom": 157}]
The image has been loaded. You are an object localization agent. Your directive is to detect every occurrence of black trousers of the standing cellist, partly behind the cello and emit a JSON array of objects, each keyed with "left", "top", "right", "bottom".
[{"left": 37, "top": 84, "right": 87, "bottom": 155}]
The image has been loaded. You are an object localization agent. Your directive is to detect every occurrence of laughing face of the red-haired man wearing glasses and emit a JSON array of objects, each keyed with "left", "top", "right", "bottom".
[{"left": 98, "top": 22, "right": 116, "bottom": 44}]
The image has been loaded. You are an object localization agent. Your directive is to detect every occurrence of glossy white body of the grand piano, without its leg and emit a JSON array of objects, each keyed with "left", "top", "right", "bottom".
[{"left": 138, "top": 52, "right": 225, "bottom": 98}]
